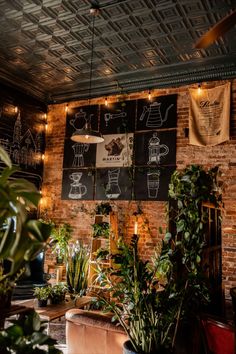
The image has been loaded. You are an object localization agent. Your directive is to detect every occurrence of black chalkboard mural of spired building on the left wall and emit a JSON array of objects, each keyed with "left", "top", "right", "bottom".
[{"left": 0, "top": 104, "right": 45, "bottom": 188}]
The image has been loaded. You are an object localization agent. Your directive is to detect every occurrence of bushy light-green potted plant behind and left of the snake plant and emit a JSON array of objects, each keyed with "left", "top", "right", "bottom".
[{"left": 50, "top": 223, "right": 72, "bottom": 263}]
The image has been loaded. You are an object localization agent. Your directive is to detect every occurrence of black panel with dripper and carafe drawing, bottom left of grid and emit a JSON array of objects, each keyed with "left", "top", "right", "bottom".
[{"left": 62, "top": 169, "right": 94, "bottom": 200}]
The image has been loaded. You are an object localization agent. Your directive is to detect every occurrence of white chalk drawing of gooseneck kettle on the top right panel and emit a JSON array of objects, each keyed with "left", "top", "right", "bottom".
[{"left": 139, "top": 102, "right": 174, "bottom": 128}]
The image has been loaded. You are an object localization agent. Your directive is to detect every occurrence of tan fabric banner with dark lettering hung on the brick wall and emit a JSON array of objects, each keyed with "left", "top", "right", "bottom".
[{"left": 189, "top": 83, "right": 230, "bottom": 146}]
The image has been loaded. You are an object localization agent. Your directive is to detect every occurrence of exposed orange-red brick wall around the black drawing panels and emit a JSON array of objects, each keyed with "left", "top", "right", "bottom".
[{"left": 41, "top": 80, "right": 236, "bottom": 294}]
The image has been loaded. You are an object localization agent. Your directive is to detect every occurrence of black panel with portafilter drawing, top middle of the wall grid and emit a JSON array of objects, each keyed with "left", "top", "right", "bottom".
[{"left": 100, "top": 100, "right": 136, "bottom": 134}]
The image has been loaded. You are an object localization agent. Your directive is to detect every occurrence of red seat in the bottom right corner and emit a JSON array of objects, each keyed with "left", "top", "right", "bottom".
[{"left": 201, "top": 316, "right": 235, "bottom": 354}]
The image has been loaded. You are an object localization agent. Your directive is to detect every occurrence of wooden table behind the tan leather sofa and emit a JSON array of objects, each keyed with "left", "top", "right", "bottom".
[{"left": 13, "top": 296, "right": 92, "bottom": 334}]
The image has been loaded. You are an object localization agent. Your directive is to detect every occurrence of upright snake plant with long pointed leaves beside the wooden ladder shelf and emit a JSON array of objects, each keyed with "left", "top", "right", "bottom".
[{"left": 66, "top": 241, "right": 90, "bottom": 297}]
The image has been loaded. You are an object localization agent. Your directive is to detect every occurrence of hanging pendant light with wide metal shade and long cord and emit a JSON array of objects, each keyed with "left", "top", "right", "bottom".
[{"left": 71, "top": 5, "right": 104, "bottom": 144}]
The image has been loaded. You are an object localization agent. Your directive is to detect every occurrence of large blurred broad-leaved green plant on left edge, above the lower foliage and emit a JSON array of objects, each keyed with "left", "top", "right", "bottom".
[{"left": 0, "top": 146, "right": 51, "bottom": 308}]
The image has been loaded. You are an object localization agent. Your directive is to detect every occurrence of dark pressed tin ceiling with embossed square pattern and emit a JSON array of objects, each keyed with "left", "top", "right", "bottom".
[{"left": 0, "top": 0, "right": 236, "bottom": 103}]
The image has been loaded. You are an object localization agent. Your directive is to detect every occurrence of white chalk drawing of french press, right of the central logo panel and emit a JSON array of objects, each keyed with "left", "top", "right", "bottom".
[{"left": 148, "top": 132, "right": 169, "bottom": 165}]
